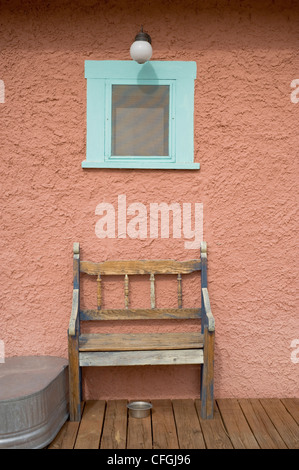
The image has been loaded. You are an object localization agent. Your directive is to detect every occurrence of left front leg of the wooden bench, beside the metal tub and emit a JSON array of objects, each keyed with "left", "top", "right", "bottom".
[{"left": 68, "top": 336, "right": 81, "bottom": 421}]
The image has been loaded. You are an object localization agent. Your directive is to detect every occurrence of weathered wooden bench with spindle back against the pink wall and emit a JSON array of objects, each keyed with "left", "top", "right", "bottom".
[{"left": 68, "top": 242, "right": 215, "bottom": 421}]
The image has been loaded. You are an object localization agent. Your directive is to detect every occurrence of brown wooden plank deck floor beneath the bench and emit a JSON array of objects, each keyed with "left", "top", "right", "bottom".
[{"left": 48, "top": 398, "right": 299, "bottom": 449}]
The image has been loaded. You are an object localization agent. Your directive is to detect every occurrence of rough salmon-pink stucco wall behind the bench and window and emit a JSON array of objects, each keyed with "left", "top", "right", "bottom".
[{"left": 0, "top": 0, "right": 299, "bottom": 398}]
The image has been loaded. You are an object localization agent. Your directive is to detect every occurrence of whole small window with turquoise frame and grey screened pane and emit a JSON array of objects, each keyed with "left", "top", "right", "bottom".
[{"left": 82, "top": 61, "right": 199, "bottom": 169}]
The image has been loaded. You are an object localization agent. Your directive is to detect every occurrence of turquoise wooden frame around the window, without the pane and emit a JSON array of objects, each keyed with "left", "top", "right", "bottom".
[{"left": 82, "top": 60, "right": 200, "bottom": 170}]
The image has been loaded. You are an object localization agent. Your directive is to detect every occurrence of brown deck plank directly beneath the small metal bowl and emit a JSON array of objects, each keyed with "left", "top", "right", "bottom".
[{"left": 127, "top": 400, "right": 153, "bottom": 449}]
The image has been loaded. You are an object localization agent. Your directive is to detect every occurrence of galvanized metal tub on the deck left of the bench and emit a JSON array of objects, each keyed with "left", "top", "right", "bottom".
[{"left": 0, "top": 356, "right": 68, "bottom": 449}]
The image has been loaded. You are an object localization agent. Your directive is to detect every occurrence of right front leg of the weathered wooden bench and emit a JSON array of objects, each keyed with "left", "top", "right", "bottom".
[{"left": 201, "top": 327, "right": 215, "bottom": 419}]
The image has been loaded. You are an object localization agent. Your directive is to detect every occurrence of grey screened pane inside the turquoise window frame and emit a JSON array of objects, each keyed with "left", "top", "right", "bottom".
[{"left": 111, "top": 85, "right": 169, "bottom": 157}]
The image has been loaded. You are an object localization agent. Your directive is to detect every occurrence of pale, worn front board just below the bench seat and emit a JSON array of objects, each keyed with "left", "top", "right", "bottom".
[{"left": 79, "top": 349, "right": 203, "bottom": 367}]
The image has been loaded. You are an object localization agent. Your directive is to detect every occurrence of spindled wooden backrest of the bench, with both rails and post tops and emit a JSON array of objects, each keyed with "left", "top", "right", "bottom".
[{"left": 73, "top": 242, "right": 207, "bottom": 321}]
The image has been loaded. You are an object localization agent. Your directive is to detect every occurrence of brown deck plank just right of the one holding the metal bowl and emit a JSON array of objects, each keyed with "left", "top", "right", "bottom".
[{"left": 152, "top": 400, "right": 179, "bottom": 449}]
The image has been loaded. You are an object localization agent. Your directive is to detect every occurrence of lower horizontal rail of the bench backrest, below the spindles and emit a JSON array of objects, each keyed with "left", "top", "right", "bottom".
[{"left": 80, "top": 308, "right": 201, "bottom": 321}]
